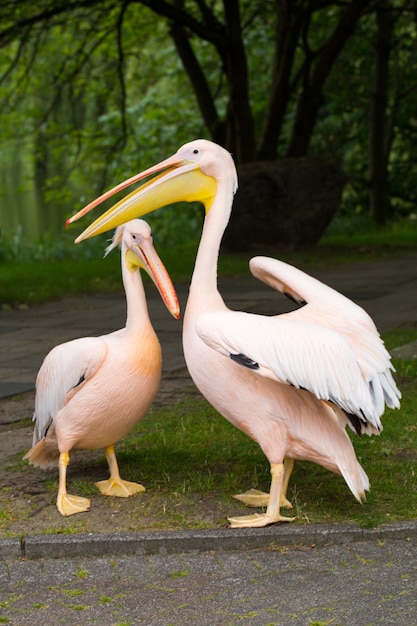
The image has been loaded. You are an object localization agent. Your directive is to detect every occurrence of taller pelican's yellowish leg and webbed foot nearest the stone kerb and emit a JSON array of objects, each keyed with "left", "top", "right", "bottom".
[{"left": 229, "top": 463, "right": 296, "bottom": 528}]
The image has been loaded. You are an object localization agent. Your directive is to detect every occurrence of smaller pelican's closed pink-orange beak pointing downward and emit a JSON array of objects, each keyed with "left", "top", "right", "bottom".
[{"left": 126, "top": 238, "right": 180, "bottom": 319}]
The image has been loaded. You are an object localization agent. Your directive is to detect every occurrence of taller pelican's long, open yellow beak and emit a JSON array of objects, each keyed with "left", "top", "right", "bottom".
[{"left": 67, "top": 154, "right": 217, "bottom": 243}]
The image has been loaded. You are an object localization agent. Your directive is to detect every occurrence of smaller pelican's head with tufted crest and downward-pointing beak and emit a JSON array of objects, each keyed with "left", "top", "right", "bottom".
[{"left": 105, "top": 219, "right": 180, "bottom": 319}]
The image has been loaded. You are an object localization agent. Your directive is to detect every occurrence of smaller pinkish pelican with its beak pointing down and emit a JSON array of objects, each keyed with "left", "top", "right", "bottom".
[{"left": 24, "top": 219, "right": 179, "bottom": 516}]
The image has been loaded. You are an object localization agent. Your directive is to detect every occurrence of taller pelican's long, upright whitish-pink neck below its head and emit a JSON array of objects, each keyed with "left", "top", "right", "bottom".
[{"left": 190, "top": 180, "right": 233, "bottom": 295}]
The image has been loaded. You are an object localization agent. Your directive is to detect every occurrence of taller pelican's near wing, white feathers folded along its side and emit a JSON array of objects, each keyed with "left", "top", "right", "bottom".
[{"left": 196, "top": 311, "right": 382, "bottom": 431}]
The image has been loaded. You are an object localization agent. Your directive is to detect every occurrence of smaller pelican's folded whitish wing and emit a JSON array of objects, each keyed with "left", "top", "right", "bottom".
[{"left": 33, "top": 337, "right": 107, "bottom": 444}]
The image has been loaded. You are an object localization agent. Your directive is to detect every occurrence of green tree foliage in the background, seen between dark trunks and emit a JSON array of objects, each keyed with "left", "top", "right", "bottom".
[{"left": 0, "top": 0, "right": 417, "bottom": 249}]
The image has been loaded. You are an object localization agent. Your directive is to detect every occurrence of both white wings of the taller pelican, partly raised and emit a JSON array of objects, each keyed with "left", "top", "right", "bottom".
[{"left": 196, "top": 257, "right": 401, "bottom": 432}]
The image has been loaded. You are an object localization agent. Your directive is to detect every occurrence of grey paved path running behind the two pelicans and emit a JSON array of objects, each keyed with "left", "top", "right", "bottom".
[{"left": 0, "top": 247, "right": 417, "bottom": 397}]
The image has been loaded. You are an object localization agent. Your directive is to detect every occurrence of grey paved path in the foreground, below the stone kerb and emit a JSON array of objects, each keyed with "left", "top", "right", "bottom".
[{"left": 0, "top": 540, "right": 417, "bottom": 626}]
